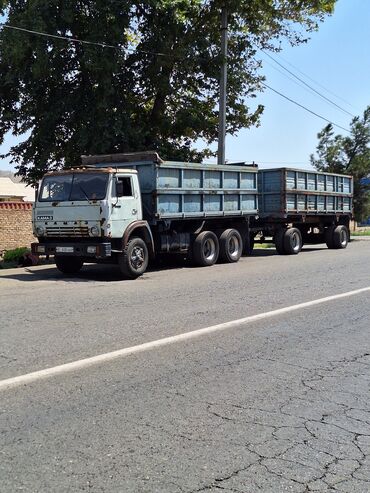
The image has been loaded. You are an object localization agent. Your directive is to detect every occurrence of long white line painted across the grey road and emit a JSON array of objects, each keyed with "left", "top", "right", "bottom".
[{"left": 0, "top": 286, "right": 370, "bottom": 391}]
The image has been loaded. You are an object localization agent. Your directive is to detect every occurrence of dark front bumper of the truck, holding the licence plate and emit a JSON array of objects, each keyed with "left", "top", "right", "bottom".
[{"left": 31, "top": 240, "right": 112, "bottom": 258}]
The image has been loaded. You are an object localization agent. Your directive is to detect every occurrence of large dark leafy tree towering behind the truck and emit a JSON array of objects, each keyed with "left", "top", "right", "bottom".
[{"left": 0, "top": 0, "right": 335, "bottom": 182}]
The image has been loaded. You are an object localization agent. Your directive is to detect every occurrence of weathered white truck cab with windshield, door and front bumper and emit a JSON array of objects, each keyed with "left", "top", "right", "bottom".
[{"left": 32, "top": 167, "right": 152, "bottom": 273}]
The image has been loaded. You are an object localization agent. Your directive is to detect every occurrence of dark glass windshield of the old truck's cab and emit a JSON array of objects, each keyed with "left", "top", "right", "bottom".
[{"left": 39, "top": 173, "right": 108, "bottom": 202}]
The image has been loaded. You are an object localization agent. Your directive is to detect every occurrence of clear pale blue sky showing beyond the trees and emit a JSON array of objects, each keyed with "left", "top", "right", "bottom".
[{"left": 0, "top": 0, "right": 370, "bottom": 170}]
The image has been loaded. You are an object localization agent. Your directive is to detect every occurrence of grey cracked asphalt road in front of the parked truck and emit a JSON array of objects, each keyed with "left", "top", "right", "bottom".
[{"left": 0, "top": 241, "right": 370, "bottom": 493}]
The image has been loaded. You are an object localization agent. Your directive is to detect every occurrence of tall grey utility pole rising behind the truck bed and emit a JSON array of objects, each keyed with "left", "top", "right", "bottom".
[{"left": 217, "top": 6, "right": 227, "bottom": 164}]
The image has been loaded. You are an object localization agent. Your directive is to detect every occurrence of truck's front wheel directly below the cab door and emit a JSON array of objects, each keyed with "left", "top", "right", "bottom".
[{"left": 118, "top": 237, "right": 149, "bottom": 279}]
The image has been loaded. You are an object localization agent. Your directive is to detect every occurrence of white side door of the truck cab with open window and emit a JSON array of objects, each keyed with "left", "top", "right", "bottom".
[{"left": 111, "top": 175, "right": 142, "bottom": 238}]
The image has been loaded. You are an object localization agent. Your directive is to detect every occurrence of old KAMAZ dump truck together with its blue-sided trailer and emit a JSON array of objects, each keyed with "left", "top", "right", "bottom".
[{"left": 32, "top": 152, "right": 352, "bottom": 279}]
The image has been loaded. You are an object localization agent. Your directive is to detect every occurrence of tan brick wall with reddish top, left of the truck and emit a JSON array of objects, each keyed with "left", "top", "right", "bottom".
[{"left": 0, "top": 202, "right": 36, "bottom": 252}]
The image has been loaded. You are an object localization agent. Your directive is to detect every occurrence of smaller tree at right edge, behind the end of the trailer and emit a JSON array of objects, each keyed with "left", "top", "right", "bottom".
[{"left": 311, "top": 106, "right": 370, "bottom": 221}]
